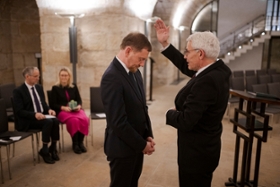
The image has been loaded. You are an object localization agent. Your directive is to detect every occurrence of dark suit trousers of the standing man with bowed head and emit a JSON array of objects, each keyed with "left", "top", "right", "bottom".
[{"left": 108, "top": 153, "right": 144, "bottom": 187}]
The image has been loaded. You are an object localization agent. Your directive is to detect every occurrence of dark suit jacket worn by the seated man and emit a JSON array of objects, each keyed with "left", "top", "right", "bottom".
[{"left": 13, "top": 83, "right": 50, "bottom": 131}]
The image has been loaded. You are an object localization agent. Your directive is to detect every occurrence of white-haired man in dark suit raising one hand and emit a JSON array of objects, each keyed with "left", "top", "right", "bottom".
[{"left": 155, "top": 19, "right": 231, "bottom": 187}]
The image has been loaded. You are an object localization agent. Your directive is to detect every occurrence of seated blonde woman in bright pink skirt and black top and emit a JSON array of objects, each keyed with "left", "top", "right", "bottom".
[{"left": 50, "top": 67, "right": 89, "bottom": 154}]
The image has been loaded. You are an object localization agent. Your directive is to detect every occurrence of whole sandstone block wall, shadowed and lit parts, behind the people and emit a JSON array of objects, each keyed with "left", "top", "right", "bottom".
[{"left": 0, "top": 0, "right": 184, "bottom": 108}]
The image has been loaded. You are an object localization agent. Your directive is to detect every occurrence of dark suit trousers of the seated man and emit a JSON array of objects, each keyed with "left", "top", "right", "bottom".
[{"left": 29, "top": 118, "right": 59, "bottom": 143}]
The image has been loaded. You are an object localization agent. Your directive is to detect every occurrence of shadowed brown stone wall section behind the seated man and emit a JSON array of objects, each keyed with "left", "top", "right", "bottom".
[{"left": 0, "top": 0, "right": 41, "bottom": 85}]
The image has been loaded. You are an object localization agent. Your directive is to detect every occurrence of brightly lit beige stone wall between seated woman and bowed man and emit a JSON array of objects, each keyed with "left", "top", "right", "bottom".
[{"left": 40, "top": 9, "right": 149, "bottom": 108}]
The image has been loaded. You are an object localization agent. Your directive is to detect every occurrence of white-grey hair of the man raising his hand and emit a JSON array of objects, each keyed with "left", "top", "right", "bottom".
[{"left": 187, "top": 31, "right": 220, "bottom": 59}]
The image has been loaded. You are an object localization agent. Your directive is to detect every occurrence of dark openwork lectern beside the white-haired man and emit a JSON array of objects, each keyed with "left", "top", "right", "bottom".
[{"left": 225, "top": 90, "right": 280, "bottom": 187}]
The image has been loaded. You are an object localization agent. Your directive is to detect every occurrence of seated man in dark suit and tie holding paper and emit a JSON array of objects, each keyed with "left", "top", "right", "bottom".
[{"left": 13, "top": 67, "right": 59, "bottom": 164}]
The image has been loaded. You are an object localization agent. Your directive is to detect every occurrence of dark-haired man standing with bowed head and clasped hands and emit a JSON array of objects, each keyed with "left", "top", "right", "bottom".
[{"left": 101, "top": 32, "right": 155, "bottom": 187}]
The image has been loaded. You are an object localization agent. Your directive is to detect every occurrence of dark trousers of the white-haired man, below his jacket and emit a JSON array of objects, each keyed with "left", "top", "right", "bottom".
[{"left": 179, "top": 166, "right": 213, "bottom": 187}]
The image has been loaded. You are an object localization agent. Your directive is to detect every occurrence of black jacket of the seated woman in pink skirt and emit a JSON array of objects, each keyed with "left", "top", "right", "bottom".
[{"left": 49, "top": 84, "right": 82, "bottom": 115}]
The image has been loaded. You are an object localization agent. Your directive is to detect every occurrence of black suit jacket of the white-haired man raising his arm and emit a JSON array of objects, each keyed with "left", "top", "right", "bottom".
[{"left": 162, "top": 45, "right": 231, "bottom": 173}]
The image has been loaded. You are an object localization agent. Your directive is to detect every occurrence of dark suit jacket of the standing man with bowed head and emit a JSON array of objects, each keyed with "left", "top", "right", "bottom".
[{"left": 101, "top": 58, "right": 153, "bottom": 158}]
